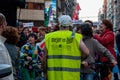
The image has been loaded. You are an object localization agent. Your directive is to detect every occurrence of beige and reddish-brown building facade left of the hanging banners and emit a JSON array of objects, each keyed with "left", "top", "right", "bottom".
[{"left": 17, "top": 0, "right": 44, "bottom": 26}]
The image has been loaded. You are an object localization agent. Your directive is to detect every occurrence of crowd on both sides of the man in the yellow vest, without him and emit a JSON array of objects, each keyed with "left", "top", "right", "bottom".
[{"left": 1, "top": 12, "right": 120, "bottom": 80}]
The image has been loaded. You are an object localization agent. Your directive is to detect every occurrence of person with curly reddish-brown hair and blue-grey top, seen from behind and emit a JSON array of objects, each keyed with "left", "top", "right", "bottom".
[{"left": 2, "top": 26, "right": 19, "bottom": 80}]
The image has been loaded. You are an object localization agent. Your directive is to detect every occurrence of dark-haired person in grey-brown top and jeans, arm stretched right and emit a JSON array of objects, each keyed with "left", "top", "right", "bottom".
[{"left": 77, "top": 23, "right": 117, "bottom": 80}]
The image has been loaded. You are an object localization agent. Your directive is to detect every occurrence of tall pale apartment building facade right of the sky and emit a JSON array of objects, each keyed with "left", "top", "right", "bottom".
[{"left": 99, "top": 0, "right": 120, "bottom": 30}]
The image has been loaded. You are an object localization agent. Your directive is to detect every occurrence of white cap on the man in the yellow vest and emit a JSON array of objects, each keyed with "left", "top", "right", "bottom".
[{"left": 58, "top": 15, "right": 72, "bottom": 26}]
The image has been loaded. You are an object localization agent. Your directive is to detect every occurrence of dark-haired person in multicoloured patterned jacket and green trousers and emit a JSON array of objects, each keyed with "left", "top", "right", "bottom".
[{"left": 20, "top": 33, "right": 38, "bottom": 80}]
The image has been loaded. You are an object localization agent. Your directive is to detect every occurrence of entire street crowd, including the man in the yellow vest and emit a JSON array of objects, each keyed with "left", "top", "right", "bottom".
[{"left": 0, "top": 13, "right": 120, "bottom": 80}]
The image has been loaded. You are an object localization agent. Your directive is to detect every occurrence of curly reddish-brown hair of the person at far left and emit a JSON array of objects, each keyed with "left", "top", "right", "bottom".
[{"left": 2, "top": 26, "right": 19, "bottom": 44}]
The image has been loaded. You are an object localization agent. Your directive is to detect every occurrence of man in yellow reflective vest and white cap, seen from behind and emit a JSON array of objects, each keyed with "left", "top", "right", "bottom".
[{"left": 45, "top": 15, "right": 89, "bottom": 80}]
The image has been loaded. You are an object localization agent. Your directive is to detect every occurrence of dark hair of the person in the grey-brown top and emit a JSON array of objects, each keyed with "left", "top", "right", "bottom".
[{"left": 78, "top": 23, "right": 93, "bottom": 38}]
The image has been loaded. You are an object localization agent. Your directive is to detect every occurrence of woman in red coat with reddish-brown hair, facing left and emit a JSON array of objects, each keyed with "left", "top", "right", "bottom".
[{"left": 94, "top": 19, "right": 116, "bottom": 80}]
